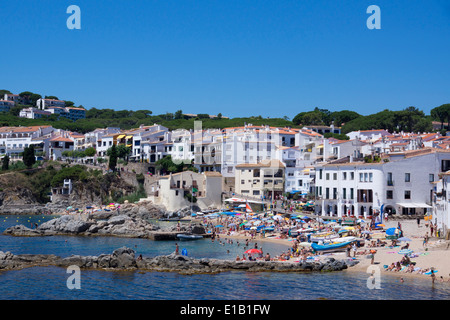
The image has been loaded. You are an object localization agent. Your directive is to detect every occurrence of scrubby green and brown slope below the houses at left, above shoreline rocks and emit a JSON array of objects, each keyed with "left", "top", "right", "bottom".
[{"left": 0, "top": 163, "right": 136, "bottom": 214}]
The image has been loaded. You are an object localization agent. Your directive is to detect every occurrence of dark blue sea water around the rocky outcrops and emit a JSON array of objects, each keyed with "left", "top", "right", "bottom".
[{"left": 0, "top": 215, "right": 450, "bottom": 302}]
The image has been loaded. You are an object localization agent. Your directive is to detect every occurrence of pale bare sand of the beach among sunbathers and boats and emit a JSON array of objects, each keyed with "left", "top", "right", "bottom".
[{"left": 200, "top": 214, "right": 450, "bottom": 285}]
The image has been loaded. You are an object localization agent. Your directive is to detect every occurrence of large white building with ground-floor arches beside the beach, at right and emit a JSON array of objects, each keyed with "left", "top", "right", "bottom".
[{"left": 315, "top": 148, "right": 450, "bottom": 217}]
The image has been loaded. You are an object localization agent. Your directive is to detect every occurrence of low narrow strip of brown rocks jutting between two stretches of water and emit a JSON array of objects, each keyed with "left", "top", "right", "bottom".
[{"left": 0, "top": 247, "right": 357, "bottom": 274}]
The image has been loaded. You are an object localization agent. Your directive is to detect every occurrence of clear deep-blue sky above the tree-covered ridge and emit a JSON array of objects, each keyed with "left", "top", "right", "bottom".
[{"left": 0, "top": 0, "right": 450, "bottom": 119}]
